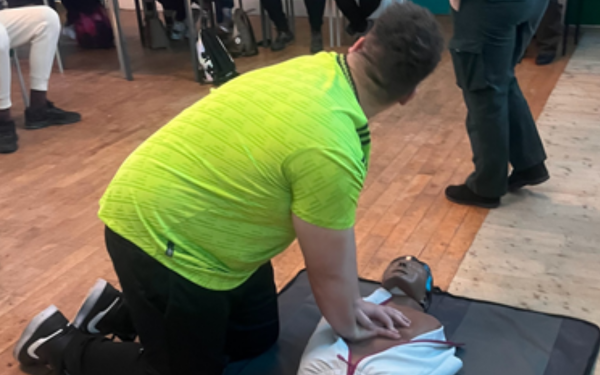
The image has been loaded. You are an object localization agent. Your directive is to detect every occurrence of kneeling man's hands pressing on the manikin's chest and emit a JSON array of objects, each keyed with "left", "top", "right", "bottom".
[{"left": 346, "top": 299, "right": 411, "bottom": 341}]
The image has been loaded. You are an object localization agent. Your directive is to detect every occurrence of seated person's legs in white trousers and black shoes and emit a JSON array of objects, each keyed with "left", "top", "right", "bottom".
[{"left": 0, "top": 0, "right": 81, "bottom": 153}]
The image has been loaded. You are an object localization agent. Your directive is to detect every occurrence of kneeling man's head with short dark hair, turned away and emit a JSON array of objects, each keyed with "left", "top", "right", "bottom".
[{"left": 360, "top": 1, "right": 444, "bottom": 103}]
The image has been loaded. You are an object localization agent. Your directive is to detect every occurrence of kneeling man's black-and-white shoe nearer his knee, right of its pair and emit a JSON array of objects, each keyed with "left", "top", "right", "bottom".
[{"left": 73, "top": 279, "right": 137, "bottom": 341}]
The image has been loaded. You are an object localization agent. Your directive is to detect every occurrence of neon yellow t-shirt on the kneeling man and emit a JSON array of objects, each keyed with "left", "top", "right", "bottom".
[{"left": 99, "top": 53, "right": 370, "bottom": 290}]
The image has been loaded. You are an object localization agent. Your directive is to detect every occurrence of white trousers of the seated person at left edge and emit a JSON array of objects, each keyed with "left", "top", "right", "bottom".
[{"left": 0, "top": 6, "right": 60, "bottom": 109}]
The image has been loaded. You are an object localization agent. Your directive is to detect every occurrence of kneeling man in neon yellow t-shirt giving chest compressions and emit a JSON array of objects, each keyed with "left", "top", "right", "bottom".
[{"left": 14, "top": 3, "right": 444, "bottom": 375}]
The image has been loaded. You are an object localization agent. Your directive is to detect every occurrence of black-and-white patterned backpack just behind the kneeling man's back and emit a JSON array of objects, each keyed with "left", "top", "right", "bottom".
[{"left": 196, "top": 27, "right": 239, "bottom": 86}]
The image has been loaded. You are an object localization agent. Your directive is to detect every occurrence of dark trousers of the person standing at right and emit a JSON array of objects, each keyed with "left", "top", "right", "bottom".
[{"left": 450, "top": 0, "right": 548, "bottom": 198}]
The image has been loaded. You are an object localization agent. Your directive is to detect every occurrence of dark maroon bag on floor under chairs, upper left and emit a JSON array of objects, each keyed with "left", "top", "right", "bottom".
[{"left": 73, "top": 6, "right": 114, "bottom": 49}]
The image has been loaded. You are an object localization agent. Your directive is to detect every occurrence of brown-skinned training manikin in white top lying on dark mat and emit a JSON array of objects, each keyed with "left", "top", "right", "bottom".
[{"left": 298, "top": 256, "right": 462, "bottom": 375}]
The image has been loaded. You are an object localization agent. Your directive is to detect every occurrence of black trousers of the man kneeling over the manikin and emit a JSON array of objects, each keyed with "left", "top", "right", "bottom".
[{"left": 63, "top": 228, "right": 279, "bottom": 375}]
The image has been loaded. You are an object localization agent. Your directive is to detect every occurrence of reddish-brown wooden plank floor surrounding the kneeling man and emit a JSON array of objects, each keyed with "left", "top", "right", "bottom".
[{"left": 0, "top": 12, "right": 565, "bottom": 374}]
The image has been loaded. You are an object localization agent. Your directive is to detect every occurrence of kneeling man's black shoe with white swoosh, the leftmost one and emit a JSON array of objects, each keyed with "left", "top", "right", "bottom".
[{"left": 13, "top": 306, "right": 75, "bottom": 368}]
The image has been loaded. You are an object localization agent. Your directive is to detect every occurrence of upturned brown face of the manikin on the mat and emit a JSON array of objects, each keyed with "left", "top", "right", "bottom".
[{"left": 381, "top": 256, "right": 429, "bottom": 303}]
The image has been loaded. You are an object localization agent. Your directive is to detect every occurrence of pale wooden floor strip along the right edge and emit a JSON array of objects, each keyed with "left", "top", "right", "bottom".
[{"left": 451, "top": 29, "right": 600, "bottom": 375}]
